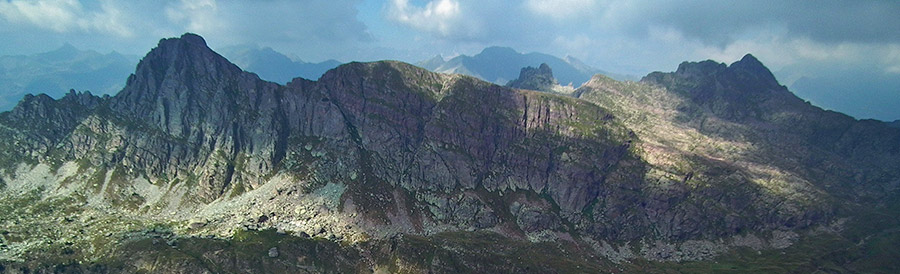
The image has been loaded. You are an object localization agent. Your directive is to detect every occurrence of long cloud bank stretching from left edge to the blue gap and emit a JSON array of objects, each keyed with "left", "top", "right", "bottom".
[{"left": 0, "top": 0, "right": 374, "bottom": 60}]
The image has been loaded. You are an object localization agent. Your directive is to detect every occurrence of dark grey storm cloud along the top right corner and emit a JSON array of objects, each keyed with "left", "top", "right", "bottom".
[{"left": 611, "top": 0, "right": 900, "bottom": 45}]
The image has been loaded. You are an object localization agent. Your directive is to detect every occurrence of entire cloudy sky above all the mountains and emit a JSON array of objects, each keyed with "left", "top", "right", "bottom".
[{"left": 0, "top": 0, "right": 900, "bottom": 120}]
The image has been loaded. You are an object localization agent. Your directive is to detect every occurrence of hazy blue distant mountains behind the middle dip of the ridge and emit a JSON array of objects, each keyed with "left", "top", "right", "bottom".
[{"left": 416, "top": 47, "right": 637, "bottom": 87}]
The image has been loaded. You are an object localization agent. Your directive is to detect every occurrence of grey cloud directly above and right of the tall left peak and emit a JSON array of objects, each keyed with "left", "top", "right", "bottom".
[{"left": 174, "top": 0, "right": 374, "bottom": 60}]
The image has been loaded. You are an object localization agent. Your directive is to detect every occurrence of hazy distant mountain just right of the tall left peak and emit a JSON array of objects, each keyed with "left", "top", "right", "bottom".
[{"left": 219, "top": 46, "right": 341, "bottom": 84}]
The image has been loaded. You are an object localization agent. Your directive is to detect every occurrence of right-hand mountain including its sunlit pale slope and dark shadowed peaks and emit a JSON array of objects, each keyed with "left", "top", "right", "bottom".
[{"left": 576, "top": 55, "right": 900, "bottom": 256}]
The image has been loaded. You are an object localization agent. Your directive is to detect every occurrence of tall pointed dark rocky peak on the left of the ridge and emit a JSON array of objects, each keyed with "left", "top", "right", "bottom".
[{"left": 111, "top": 33, "right": 274, "bottom": 148}]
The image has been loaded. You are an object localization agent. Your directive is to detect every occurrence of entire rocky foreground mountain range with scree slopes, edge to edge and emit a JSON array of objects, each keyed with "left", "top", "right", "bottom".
[{"left": 0, "top": 34, "right": 900, "bottom": 273}]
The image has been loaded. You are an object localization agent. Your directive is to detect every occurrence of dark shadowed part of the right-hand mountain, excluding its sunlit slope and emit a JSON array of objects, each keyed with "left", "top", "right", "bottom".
[{"left": 643, "top": 54, "right": 900, "bottom": 197}]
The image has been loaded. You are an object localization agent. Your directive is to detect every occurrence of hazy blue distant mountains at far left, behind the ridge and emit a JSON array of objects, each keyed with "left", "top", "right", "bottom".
[{"left": 0, "top": 44, "right": 139, "bottom": 111}]
